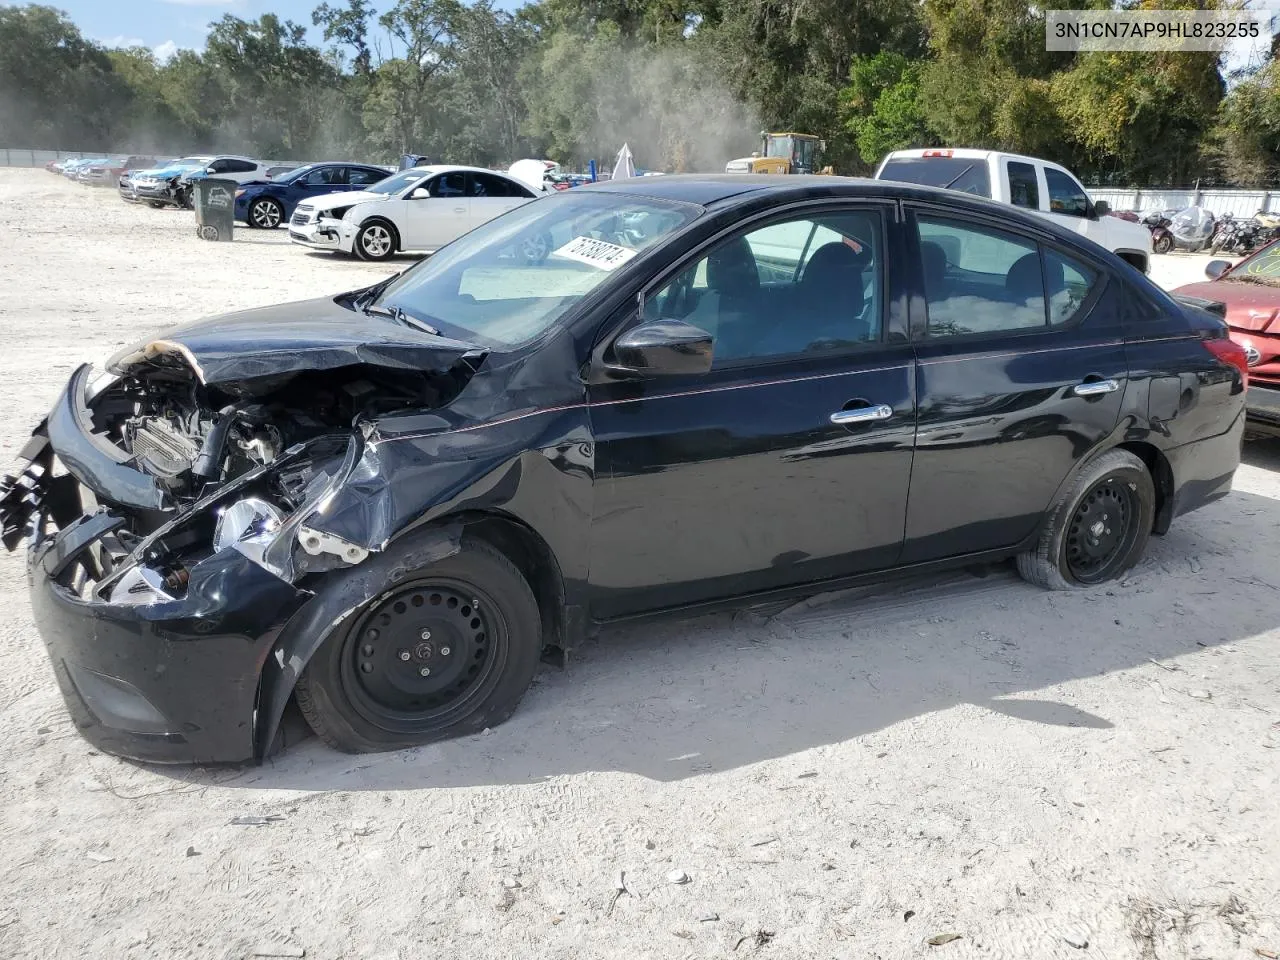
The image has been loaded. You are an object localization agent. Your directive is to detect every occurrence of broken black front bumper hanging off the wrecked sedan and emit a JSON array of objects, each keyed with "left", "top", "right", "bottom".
[{"left": 0, "top": 367, "right": 317, "bottom": 763}]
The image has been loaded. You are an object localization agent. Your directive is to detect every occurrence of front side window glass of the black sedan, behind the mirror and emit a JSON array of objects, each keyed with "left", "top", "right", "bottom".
[{"left": 644, "top": 211, "right": 883, "bottom": 369}]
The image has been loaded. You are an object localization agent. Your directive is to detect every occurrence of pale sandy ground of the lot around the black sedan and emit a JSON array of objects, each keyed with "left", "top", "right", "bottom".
[{"left": 0, "top": 170, "right": 1280, "bottom": 960}]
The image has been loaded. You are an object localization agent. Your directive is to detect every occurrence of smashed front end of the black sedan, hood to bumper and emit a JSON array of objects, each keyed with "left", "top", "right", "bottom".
[{"left": 0, "top": 303, "right": 484, "bottom": 762}]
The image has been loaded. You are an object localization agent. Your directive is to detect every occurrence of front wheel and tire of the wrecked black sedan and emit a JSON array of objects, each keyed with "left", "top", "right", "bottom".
[{"left": 294, "top": 539, "right": 541, "bottom": 753}]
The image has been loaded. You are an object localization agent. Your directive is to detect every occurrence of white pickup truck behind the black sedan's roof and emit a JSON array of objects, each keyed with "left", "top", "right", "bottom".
[{"left": 876, "top": 148, "right": 1151, "bottom": 273}]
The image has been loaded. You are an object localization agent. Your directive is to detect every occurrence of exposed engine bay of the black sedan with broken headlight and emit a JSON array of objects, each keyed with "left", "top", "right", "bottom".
[{"left": 0, "top": 321, "right": 483, "bottom": 604}]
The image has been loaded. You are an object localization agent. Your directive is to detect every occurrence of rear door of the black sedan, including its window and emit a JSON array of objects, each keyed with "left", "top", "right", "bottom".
[{"left": 902, "top": 205, "right": 1128, "bottom": 563}]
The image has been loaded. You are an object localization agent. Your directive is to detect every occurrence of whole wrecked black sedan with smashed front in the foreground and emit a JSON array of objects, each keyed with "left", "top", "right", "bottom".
[{"left": 0, "top": 177, "right": 1245, "bottom": 762}]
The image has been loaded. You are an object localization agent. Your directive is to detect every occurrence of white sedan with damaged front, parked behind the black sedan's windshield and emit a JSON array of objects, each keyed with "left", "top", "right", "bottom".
[{"left": 289, "top": 165, "right": 547, "bottom": 260}]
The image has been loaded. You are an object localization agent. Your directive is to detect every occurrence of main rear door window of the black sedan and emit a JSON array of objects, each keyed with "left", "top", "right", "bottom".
[{"left": 918, "top": 216, "right": 1046, "bottom": 337}]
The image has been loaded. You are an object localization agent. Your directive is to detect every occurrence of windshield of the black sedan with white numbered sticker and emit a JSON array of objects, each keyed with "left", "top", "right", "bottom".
[{"left": 376, "top": 189, "right": 703, "bottom": 349}]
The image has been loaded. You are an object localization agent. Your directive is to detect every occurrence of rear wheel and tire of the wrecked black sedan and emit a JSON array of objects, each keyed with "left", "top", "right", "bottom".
[{"left": 1018, "top": 451, "right": 1156, "bottom": 590}]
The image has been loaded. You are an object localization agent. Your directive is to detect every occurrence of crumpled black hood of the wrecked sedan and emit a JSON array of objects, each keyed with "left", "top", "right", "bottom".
[{"left": 108, "top": 297, "right": 486, "bottom": 384}]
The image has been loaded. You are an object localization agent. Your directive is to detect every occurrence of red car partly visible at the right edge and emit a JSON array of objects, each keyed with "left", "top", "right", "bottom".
[{"left": 1174, "top": 241, "right": 1280, "bottom": 436}]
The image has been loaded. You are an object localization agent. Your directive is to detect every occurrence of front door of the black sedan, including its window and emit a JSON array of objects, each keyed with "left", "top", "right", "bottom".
[{"left": 590, "top": 205, "right": 915, "bottom": 617}]
